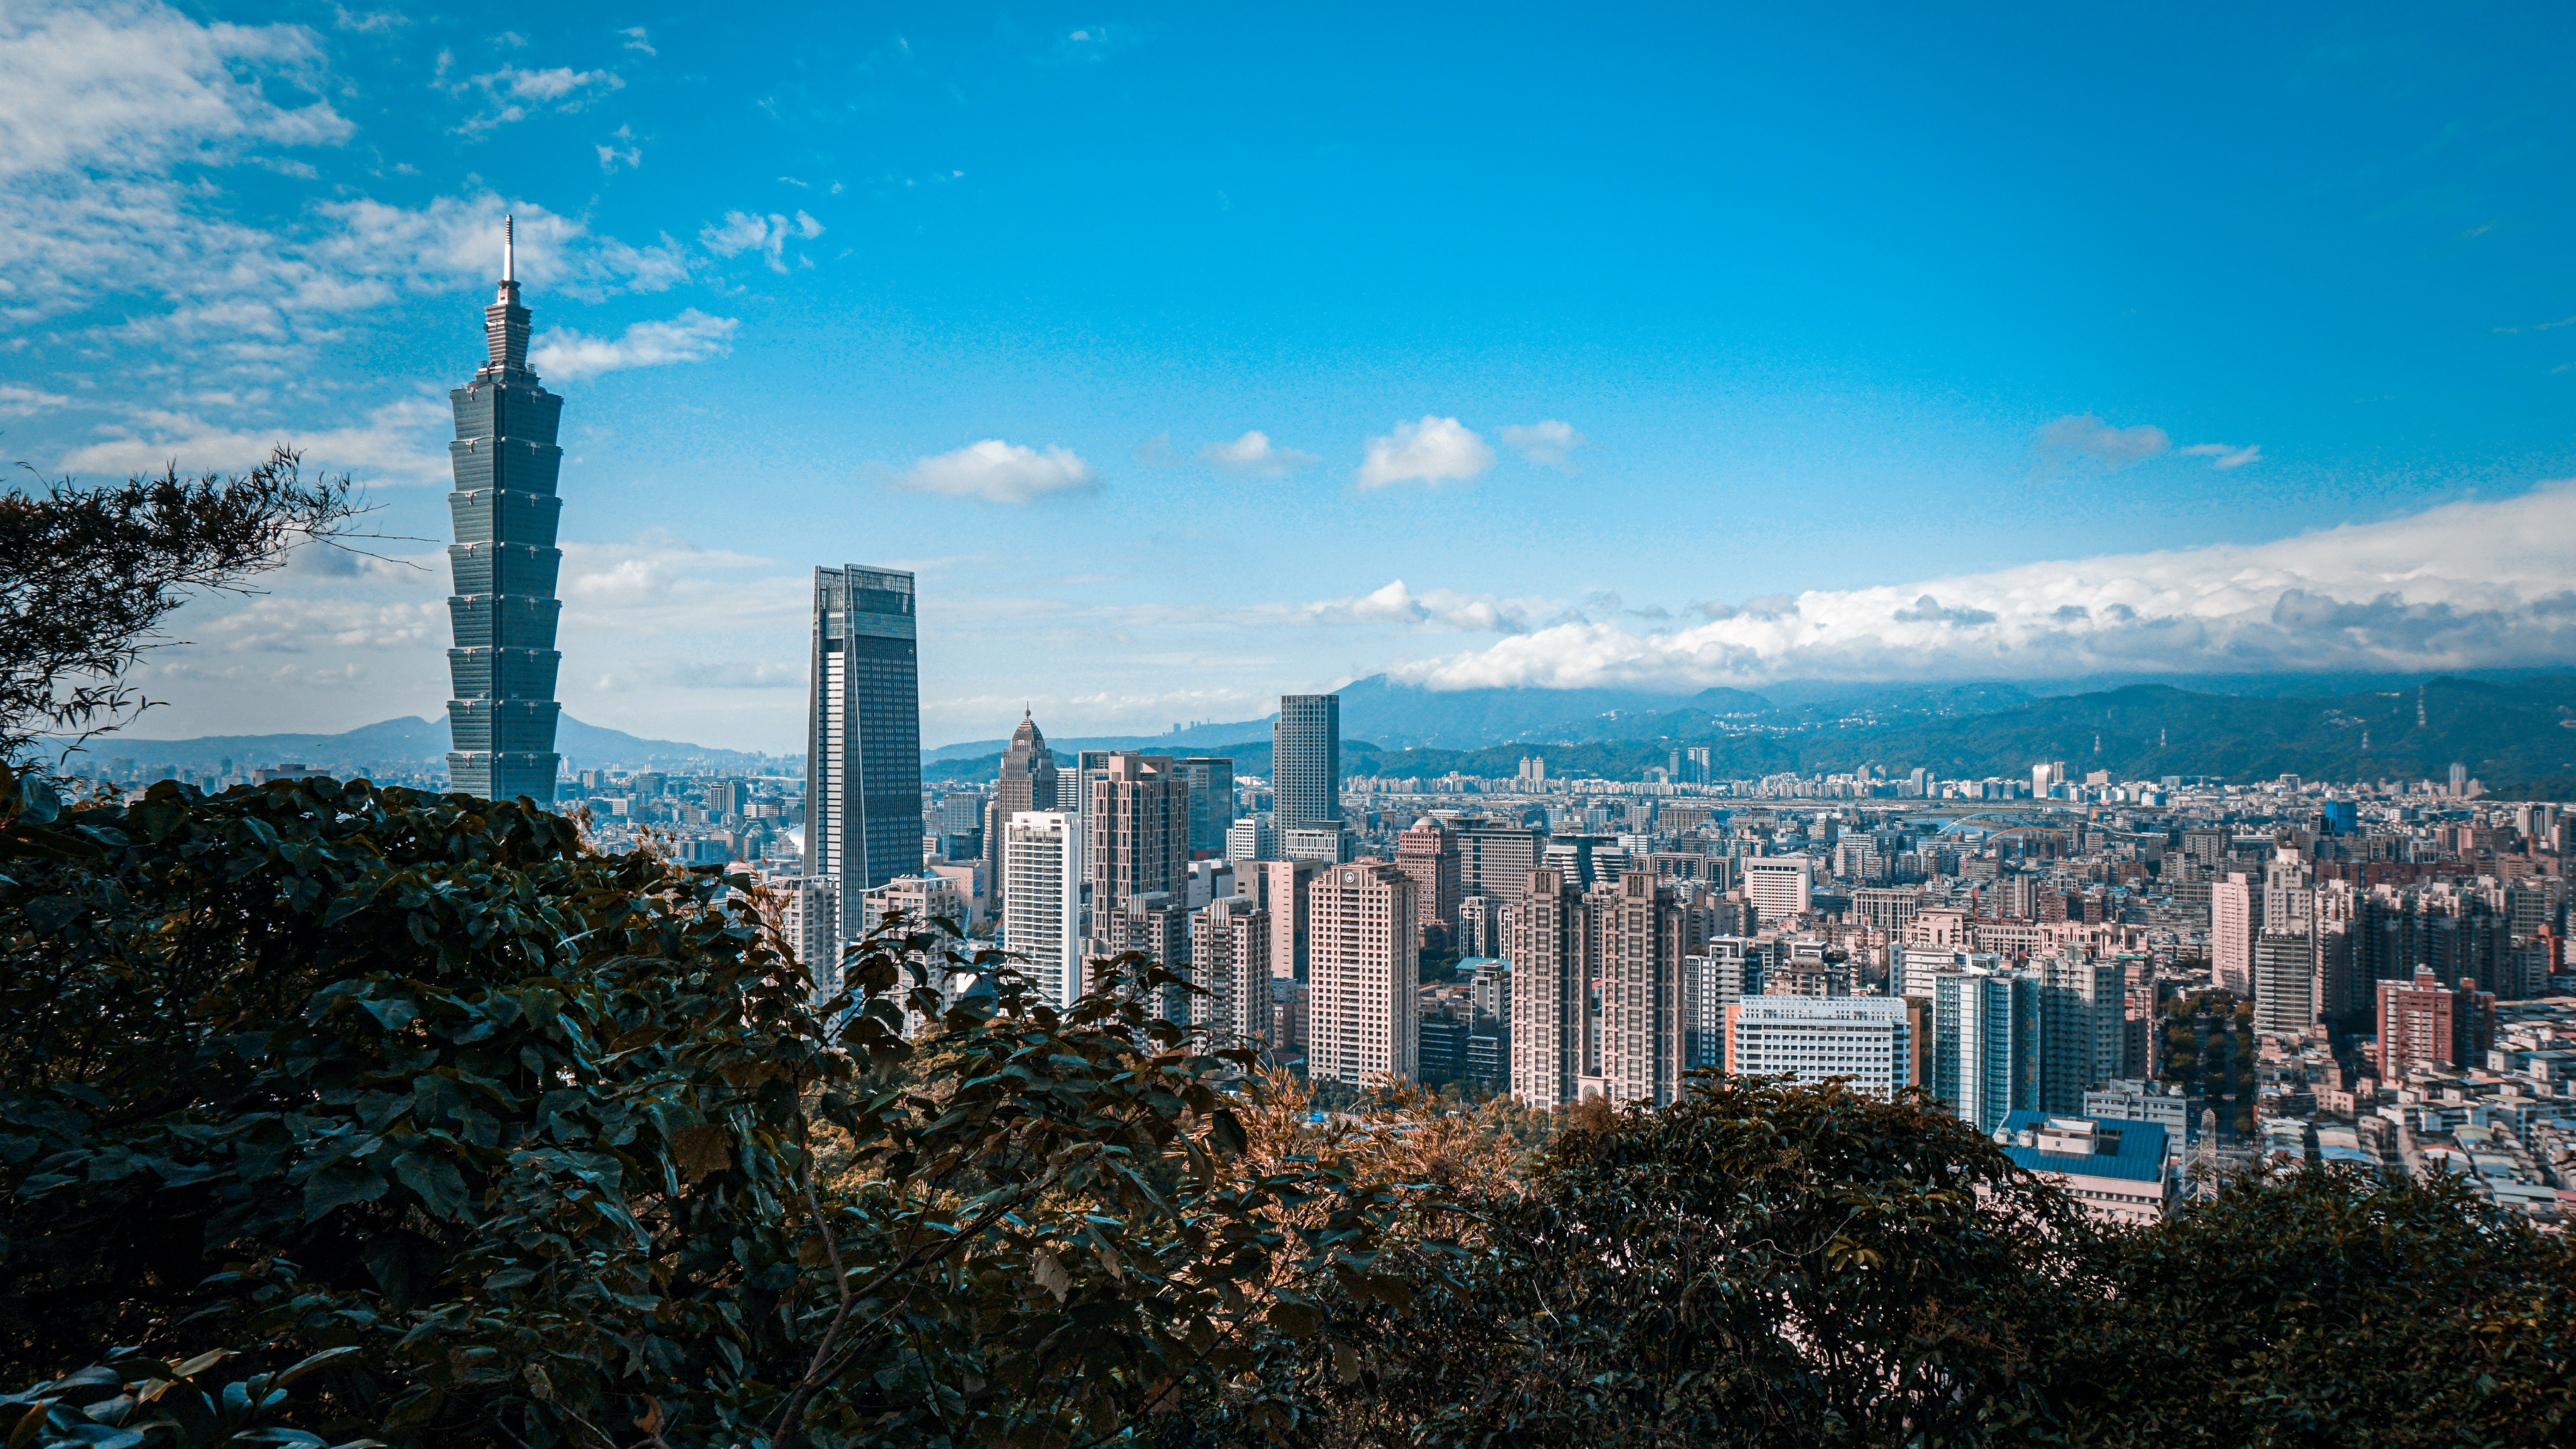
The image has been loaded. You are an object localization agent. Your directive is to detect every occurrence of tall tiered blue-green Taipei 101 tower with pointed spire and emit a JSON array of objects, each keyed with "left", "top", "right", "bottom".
[{"left": 448, "top": 217, "right": 564, "bottom": 804}]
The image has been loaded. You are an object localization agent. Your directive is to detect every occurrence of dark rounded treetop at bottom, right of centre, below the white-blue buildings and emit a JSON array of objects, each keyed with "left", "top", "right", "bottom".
[{"left": 1256, "top": 1075, "right": 2092, "bottom": 1449}]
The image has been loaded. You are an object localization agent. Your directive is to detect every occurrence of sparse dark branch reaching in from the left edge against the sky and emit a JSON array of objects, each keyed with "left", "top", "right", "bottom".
[{"left": 0, "top": 449, "right": 358, "bottom": 761}]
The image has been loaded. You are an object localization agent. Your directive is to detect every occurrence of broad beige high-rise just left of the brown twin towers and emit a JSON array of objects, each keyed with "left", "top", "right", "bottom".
[{"left": 1306, "top": 859, "right": 1419, "bottom": 1085}]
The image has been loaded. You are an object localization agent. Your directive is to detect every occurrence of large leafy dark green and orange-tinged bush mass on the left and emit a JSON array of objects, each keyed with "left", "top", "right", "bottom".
[{"left": 0, "top": 776, "right": 1391, "bottom": 1449}]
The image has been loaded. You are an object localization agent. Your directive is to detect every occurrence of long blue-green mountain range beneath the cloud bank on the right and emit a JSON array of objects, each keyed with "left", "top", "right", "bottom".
[{"left": 922, "top": 673, "right": 2576, "bottom": 799}]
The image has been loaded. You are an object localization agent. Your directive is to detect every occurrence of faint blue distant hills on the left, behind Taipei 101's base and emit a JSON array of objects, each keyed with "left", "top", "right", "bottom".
[{"left": 60, "top": 714, "right": 801, "bottom": 773}]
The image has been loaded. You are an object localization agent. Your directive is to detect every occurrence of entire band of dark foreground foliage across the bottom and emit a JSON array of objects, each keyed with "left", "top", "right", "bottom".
[{"left": 0, "top": 763, "right": 2576, "bottom": 1449}]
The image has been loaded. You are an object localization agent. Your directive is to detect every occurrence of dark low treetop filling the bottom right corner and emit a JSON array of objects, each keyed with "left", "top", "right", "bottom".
[{"left": 2045, "top": 1163, "right": 2576, "bottom": 1449}]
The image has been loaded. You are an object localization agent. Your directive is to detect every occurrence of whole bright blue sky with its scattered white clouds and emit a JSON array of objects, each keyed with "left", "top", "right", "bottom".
[{"left": 0, "top": 0, "right": 2576, "bottom": 748}]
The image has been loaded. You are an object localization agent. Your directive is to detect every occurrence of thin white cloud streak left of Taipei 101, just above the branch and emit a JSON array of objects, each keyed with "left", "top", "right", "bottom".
[{"left": 62, "top": 397, "right": 453, "bottom": 482}]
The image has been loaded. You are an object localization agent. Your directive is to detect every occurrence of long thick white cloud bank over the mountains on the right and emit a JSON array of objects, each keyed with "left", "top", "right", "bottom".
[{"left": 1399, "top": 480, "right": 2576, "bottom": 688}]
